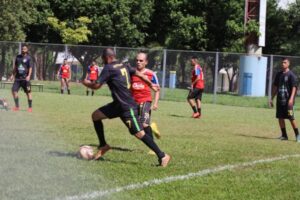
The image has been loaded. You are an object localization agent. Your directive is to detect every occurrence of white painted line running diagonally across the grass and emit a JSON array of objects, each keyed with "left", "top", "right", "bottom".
[{"left": 57, "top": 154, "right": 300, "bottom": 200}]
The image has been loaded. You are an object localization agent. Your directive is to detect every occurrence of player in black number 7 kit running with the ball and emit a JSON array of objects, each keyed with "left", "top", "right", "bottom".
[{"left": 83, "top": 48, "right": 171, "bottom": 167}]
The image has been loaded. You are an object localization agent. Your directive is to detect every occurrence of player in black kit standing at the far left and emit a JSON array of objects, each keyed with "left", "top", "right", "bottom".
[{"left": 11, "top": 45, "right": 32, "bottom": 112}]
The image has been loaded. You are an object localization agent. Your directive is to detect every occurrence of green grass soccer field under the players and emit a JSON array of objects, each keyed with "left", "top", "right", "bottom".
[{"left": 0, "top": 90, "right": 300, "bottom": 200}]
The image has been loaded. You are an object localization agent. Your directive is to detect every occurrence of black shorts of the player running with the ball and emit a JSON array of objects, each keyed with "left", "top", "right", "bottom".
[{"left": 99, "top": 101, "right": 143, "bottom": 135}]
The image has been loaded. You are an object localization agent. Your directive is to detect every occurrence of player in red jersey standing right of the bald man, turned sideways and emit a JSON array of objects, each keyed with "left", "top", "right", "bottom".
[{"left": 187, "top": 57, "right": 204, "bottom": 118}]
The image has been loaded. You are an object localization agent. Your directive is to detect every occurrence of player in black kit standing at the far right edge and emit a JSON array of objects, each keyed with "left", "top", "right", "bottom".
[{"left": 270, "top": 58, "right": 300, "bottom": 142}]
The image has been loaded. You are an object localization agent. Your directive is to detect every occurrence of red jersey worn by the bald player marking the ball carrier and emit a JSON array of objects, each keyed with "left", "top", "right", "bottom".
[{"left": 131, "top": 69, "right": 159, "bottom": 104}]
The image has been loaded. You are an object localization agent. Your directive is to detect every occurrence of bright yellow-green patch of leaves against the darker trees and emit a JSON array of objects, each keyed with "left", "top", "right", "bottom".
[{"left": 48, "top": 17, "right": 92, "bottom": 44}]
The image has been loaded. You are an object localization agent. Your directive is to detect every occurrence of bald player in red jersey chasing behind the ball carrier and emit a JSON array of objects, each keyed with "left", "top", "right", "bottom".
[{"left": 131, "top": 53, "right": 160, "bottom": 152}]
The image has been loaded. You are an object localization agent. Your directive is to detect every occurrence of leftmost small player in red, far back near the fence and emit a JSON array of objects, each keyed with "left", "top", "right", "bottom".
[{"left": 57, "top": 59, "right": 71, "bottom": 94}]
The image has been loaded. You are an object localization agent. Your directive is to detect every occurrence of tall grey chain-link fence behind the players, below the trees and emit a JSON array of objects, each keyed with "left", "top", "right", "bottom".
[{"left": 0, "top": 42, "right": 300, "bottom": 101}]
